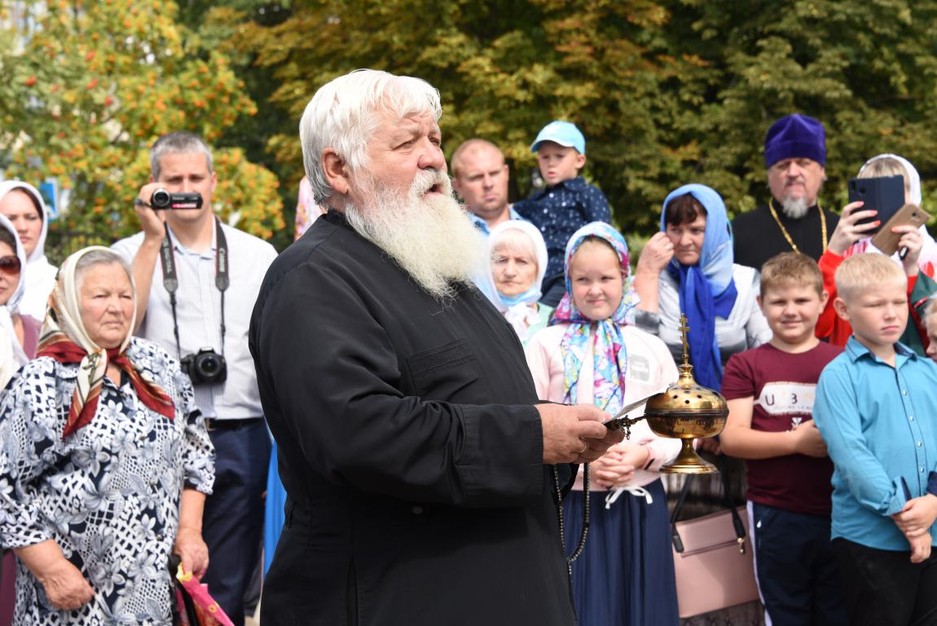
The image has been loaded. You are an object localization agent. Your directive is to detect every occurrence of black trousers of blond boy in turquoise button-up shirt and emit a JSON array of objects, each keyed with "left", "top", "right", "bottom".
[{"left": 833, "top": 538, "right": 937, "bottom": 626}]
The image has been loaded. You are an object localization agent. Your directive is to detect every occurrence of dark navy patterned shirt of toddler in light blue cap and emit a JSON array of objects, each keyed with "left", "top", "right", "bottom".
[{"left": 514, "top": 176, "right": 612, "bottom": 278}]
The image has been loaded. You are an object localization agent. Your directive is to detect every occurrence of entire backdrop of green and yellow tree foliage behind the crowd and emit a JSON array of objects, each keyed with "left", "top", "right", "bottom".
[{"left": 0, "top": 0, "right": 937, "bottom": 247}]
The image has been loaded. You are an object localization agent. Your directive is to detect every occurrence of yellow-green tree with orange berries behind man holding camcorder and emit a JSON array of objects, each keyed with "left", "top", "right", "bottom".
[{"left": 0, "top": 0, "right": 283, "bottom": 257}]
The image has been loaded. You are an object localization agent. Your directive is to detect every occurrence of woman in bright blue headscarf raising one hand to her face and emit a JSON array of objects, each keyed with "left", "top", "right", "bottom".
[{"left": 634, "top": 184, "right": 771, "bottom": 391}]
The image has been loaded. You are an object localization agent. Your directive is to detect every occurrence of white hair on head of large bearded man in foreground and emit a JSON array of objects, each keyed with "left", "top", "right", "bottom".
[{"left": 299, "top": 69, "right": 442, "bottom": 204}]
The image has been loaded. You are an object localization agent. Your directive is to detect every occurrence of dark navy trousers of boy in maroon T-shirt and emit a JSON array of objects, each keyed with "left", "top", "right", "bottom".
[{"left": 751, "top": 502, "right": 849, "bottom": 626}]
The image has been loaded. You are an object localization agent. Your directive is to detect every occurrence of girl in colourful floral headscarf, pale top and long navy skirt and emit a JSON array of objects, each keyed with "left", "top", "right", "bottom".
[{"left": 526, "top": 222, "right": 680, "bottom": 626}]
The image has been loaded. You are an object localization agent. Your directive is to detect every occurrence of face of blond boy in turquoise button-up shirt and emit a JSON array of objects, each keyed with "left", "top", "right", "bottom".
[{"left": 833, "top": 283, "right": 908, "bottom": 352}]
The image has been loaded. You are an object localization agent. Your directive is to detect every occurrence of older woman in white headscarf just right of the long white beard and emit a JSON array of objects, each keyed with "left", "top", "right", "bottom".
[{"left": 488, "top": 220, "right": 553, "bottom": 344}]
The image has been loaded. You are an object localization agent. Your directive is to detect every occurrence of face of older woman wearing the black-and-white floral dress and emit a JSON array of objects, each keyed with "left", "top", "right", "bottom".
[{"left": 76, "top": 263, "right": 133, "bottom": 348}]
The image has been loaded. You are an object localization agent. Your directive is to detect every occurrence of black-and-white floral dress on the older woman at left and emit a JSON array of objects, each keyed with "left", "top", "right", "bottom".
[{"left": 0, "top": 338, "right": 214, "bottom": 626}]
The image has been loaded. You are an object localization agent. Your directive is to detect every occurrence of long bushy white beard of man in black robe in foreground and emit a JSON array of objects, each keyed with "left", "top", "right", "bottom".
[{"left": 345, "top": 170, "right": 487, "bottom": 301}]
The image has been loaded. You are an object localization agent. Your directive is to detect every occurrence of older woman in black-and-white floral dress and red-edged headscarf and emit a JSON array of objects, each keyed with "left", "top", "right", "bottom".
[{"left": 0, "top": 247, "right": 214, "bottom": 625}]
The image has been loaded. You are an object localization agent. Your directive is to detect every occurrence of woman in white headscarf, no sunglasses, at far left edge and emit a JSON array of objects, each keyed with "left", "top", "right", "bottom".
[{"left": 0, "top": 180, "right": 57, "bottom": 322}]
